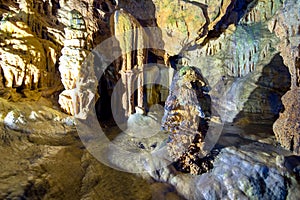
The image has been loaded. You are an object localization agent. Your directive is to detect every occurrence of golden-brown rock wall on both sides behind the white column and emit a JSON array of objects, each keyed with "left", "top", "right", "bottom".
[{"left": 0, "top": 0, "right": 117, "bottom": 101}]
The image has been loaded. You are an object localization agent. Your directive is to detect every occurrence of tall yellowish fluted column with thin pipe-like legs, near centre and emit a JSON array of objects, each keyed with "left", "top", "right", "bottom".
[{"left": 110, "top": 9, "right": 148, "bottom": 117}]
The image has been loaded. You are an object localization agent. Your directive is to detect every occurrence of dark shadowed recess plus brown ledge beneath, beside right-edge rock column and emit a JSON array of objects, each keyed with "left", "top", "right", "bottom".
[{"left": 219, "top": 53, "right": 291, "bottom": 146}]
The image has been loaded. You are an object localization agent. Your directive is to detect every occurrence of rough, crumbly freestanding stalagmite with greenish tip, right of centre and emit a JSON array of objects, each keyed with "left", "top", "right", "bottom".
[{"left": 162, "top": 67, "right": 209, "bottom": 174}]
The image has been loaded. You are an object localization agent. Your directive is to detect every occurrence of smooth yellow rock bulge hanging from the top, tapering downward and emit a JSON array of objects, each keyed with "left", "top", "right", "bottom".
[{"left": 153, "top": 0, "right": 207, "bottom": 55}]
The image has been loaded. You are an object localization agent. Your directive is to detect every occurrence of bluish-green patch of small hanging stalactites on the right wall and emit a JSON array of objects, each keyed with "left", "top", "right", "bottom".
[{"left": 223, "top": 25, "right": 277, "bottom": 77}]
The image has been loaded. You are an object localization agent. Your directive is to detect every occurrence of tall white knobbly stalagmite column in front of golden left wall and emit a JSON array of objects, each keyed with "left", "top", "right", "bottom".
[{"left": 58, "top": 10, "right": 97, "bottom": 119}]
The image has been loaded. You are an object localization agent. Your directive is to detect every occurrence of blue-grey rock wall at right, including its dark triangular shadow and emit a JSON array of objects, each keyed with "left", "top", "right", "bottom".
[{"left": 180, "top": 1, "right": 290, "bottom": 123}]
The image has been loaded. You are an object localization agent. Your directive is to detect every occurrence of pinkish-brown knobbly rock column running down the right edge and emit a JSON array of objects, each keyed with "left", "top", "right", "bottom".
[{"left": 269, "top": 0, "right": 300, "bottom": 154}]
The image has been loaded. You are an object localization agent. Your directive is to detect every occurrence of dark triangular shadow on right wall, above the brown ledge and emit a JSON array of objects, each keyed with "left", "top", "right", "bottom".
[{"left": 237, "top": 53, "right": 291, "bottom": 124}]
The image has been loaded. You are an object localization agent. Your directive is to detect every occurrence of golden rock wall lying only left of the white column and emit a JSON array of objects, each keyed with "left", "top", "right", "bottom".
[{"left": 0, "top": 0, "right": 62, "bottom": 101}]
